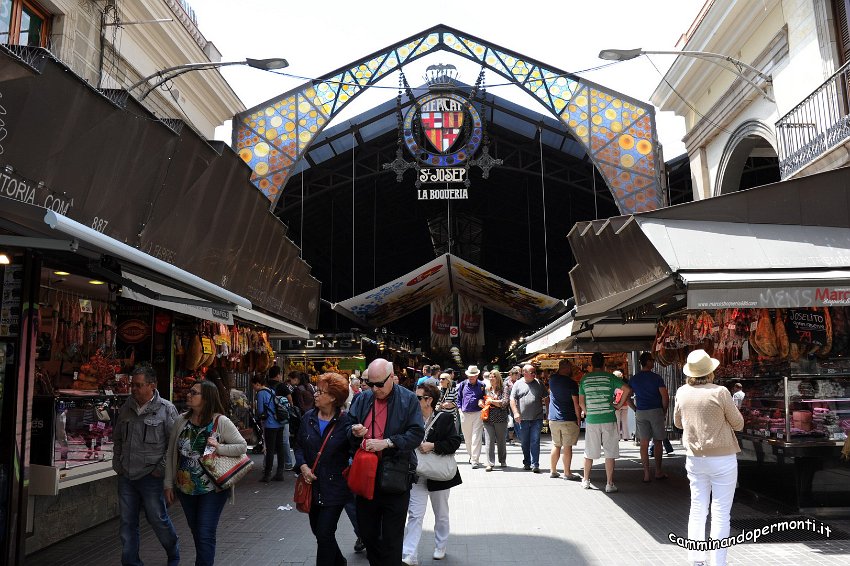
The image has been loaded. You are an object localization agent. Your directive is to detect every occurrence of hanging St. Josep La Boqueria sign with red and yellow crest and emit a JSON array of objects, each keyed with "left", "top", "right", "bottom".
[{"left": 383, "top": 64, "right": 502, "bottom": 200}]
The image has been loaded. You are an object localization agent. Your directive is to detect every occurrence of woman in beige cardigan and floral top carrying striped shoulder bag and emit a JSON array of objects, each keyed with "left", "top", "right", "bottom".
[{"left": 164, "top": 381, "right": 248, "bottom": 566}]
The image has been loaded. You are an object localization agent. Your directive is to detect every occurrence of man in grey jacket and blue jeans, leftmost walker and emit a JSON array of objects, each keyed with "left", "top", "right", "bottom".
[{"left": 112, "top": 367, "right": 180, "bottom": 566}]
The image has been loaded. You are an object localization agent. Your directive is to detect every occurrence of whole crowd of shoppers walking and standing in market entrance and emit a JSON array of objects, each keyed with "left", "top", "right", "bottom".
[{"left": 113, "top": 350, "right": 743, "bottom": 566}]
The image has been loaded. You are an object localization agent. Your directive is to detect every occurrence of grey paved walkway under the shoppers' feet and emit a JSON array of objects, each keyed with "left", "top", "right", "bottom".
[{"left": 26, "top": 437, "right": 850, "bottom": 566}]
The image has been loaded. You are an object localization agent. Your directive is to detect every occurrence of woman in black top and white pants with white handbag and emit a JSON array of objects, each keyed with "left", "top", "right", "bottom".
[{"left": 402, "top": 384, "right": 462, "bottom": 566}]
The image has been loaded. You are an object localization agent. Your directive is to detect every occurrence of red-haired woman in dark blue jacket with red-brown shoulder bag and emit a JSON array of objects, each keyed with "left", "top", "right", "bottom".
[{"left": 295, "top": 373, "right": 352, "bottom": 566}]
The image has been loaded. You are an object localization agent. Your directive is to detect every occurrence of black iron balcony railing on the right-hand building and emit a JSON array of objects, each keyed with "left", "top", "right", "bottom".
[{"left": 776, "top": 62, "right": 850, "bottom": 179}]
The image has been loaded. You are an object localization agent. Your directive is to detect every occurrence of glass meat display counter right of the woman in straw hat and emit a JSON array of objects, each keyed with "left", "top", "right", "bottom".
[{"left": 733, "top": 373, "right": 850, "bottom": 515}]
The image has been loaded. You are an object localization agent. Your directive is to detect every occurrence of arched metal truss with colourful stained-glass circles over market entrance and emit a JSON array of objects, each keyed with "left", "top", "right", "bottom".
[{"left": 233, "top": 25, "right": 662, "bottom": 214}]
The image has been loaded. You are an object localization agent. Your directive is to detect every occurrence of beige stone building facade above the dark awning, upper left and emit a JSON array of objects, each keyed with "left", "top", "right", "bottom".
[{"left": 0, "top": 0, "right": 245, "bottom": 139}]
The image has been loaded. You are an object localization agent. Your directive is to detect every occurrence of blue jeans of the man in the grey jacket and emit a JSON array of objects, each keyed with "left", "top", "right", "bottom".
[{"left": 118, "top": 474, "right": 180, "bottom": 566}]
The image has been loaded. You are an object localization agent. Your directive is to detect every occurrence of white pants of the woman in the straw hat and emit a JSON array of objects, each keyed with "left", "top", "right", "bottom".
[{"left": 685, "top": 454, "right": 738, "bottom": 566}]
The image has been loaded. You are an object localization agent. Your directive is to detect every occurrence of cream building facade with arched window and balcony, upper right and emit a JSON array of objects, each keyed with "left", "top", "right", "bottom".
[{"left": 651, "top": 0, "right": 850, "bottom": 200}]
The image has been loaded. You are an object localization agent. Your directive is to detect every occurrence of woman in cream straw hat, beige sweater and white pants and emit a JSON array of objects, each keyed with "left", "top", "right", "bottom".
[{"left": 673, "top": 350, "right": 744, "bottom": 566}]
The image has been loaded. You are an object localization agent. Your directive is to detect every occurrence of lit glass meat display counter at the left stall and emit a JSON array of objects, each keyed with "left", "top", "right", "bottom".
[{"left": 30, "top": 389, "right": 127, "bottom": 495}]
